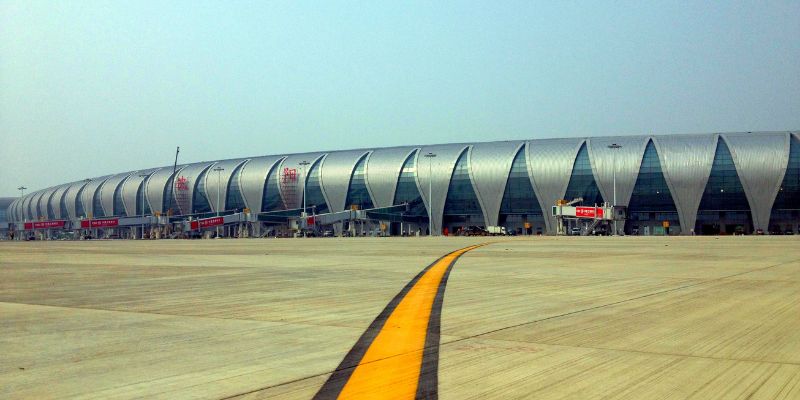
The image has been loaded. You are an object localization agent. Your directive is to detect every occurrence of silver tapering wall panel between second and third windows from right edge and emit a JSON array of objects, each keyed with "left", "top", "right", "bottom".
[{"left": 653, "top": 134, "right": 718, "bottom": 229}]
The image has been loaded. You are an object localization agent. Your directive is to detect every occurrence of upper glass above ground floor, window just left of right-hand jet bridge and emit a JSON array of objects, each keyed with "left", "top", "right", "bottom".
[{"left": 500, "top": 147, "right": 544, "bottom": 216}]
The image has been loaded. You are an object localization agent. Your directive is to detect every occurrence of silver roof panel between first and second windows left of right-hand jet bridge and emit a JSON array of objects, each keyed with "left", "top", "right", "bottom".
[{"left": 469, "top": 141, "right": 525, "bottom": 226}]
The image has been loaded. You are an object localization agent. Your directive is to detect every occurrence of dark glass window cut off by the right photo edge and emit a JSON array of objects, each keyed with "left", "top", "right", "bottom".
[{"left": 769, "top": 136, "right": 800, "bottom": 234}]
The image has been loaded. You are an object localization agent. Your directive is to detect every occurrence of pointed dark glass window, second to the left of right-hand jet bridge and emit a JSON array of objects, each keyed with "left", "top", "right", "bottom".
[{"left": 443, "top": 149, "right": 483, "bottom": 233}]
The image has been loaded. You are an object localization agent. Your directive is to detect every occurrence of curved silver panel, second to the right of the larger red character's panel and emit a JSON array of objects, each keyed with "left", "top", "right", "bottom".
[{"left": 366, "top": 147, "right": 417, "bottom": 207}]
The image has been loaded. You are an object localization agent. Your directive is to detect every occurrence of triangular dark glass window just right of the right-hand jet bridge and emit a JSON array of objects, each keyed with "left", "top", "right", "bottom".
[{"left": 628, "top": 141, "right": 679, "bottom": 226}]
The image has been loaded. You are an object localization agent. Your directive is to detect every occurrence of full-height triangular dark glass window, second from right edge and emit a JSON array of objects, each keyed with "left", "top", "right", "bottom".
[{"left": 695, "top": 139, "right": 753, "bottom": 235}]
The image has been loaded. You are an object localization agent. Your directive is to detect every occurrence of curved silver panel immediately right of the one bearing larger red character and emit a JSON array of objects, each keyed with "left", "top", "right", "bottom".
[{"left": 320, "top": 150, "right": 368, "bottom": 212}]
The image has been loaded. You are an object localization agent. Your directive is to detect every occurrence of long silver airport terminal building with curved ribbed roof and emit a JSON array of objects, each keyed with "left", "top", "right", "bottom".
[{"left": 7, "top": 132, "right": 800, "bottom": 237}]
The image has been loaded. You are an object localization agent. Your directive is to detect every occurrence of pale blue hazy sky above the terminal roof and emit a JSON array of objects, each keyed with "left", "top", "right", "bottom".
[{"left": 0, "top": 0, "right": 800, "bottom": 196}]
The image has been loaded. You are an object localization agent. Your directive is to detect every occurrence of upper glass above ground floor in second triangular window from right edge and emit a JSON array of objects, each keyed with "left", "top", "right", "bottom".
[{"left": 699, "top": 139, "right": 750, "bottom": 211}]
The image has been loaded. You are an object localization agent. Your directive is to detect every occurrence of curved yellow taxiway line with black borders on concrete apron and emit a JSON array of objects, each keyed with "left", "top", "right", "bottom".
[{"left": 314, "top": 244, "right": 486, "bottom": 400}]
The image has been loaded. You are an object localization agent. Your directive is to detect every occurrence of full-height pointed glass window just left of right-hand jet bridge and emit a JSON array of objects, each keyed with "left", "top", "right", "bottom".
[{"left": 498, "top": 147, "right": 545, "bottom": 234}]
